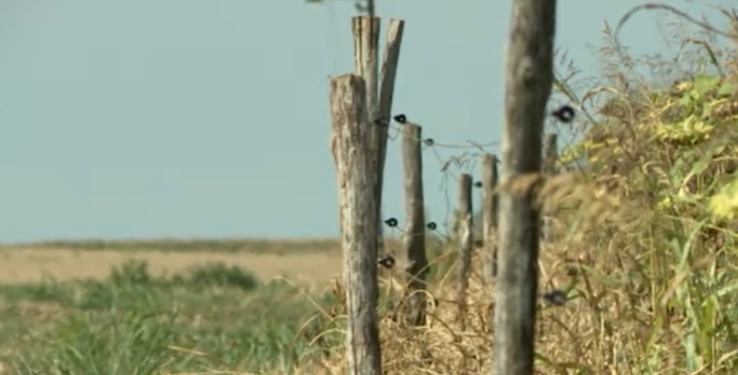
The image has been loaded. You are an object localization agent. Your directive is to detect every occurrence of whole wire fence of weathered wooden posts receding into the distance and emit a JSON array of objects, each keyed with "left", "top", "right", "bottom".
[{"left": 330, "top": 9, "right": 556, "bottom": 375}]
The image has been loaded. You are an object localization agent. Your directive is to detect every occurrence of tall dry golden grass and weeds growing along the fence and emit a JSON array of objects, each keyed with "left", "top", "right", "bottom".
[{"left": 286, "top": 8, "right": 738, "bottom": 375}]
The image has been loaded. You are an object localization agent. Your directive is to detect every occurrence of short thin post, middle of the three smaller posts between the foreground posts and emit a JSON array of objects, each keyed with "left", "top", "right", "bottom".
[{"left": 457, "top": 173, "right": 474, "bottom": 329}]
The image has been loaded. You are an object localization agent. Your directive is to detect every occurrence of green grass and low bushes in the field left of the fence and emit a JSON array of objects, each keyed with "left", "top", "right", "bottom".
[{"left": 0, "top": 262, "right": 338, "bottom": 375}]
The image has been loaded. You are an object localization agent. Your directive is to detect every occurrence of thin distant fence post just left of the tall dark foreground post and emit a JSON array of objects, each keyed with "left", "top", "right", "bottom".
[{"left": 482, "top": 153, "right": 498, "bottom": 283}]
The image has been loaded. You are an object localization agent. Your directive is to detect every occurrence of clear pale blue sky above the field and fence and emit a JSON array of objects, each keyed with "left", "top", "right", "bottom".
[{"left": 0, "top": 0, "right": 729, "bottom": 242}]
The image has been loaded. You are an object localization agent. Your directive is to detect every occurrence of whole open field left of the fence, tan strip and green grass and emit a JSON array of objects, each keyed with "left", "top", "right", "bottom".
[{"left": 0, "top": 241, "right": 348, "bottom": 375}]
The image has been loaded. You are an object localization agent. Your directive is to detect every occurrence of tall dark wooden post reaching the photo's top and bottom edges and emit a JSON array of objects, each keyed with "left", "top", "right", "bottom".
[{"left": 493, "top": 0, "right": 556, "bottom": 375}]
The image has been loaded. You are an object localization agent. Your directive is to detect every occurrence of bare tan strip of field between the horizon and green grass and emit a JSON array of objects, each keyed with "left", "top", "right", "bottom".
[{"left": 0, "top": 248, "right": 341, "bottom": 284}]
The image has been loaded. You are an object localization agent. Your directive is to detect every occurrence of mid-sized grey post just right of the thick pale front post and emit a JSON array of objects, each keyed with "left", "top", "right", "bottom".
[{"left": 402, "top": 123, "right": 428, "bottom": 326}]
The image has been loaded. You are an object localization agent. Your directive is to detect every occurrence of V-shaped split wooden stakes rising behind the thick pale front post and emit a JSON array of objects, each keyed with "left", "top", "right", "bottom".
[{"left": 351, "top": 14, "right": 404, "bottom": 258}]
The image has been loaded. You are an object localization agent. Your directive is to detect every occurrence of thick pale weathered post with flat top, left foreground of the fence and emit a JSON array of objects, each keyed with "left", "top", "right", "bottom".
[{"left": 330, "top": 74, "right": 382, "bottom": 375}]
